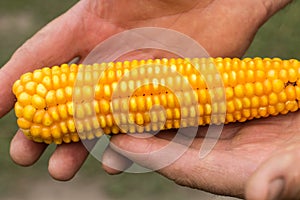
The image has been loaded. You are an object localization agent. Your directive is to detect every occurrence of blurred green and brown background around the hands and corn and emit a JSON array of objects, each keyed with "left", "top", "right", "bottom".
[{"left": 0, "top": 0, "right": 300, "bottom": 200}]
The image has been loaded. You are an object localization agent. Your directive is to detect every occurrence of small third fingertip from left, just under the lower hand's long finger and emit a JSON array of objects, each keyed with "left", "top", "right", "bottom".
[{"left": 102, "top": 147, "right": 132, "bottom": 175}]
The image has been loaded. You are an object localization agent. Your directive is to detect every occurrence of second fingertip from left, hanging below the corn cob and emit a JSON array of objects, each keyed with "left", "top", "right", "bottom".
[{"left": 48, "top": 142, "right": 88, "bottom": 181}]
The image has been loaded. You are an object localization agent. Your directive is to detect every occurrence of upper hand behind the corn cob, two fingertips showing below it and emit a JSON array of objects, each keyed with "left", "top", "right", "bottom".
[{"left": 0, "top": 0, "right": 288, "bottom": 197}]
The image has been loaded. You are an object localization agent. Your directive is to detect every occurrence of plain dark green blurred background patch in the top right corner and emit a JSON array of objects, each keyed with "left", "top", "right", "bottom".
[{"left": 245, "top": 1, "right": 300, "bottom": 59}]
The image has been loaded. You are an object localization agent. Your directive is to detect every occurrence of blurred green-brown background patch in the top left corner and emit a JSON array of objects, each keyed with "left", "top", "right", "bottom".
[{"left": 0, "top": 0, "right": 77, "bottom": 66}]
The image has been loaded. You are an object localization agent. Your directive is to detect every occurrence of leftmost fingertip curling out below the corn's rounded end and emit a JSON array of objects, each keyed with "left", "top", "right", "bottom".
[{"left": 10, "top": 130, "right": 47, "bottom": 166}]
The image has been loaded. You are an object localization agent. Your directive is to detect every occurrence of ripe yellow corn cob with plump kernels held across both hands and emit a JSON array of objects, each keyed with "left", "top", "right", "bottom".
[{"left": 13, "top": 58, "right": 300, "bottom": 144}]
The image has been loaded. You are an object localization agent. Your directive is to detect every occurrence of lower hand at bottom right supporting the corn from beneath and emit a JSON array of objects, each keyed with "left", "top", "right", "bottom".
[{"left": 103, "top": 112, "right": 300, "bottom": 200}]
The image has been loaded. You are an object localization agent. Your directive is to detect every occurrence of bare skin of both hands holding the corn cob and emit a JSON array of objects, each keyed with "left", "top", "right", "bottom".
[{"left": 0, "top": 0, "right": 300, "bottom": 199}]
